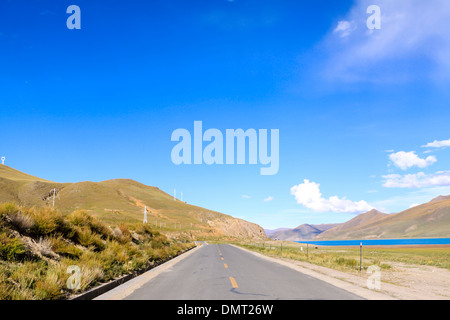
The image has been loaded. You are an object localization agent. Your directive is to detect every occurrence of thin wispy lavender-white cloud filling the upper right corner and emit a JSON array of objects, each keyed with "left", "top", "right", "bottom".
[{"left": 324, "top": 0, "right": 450, "bottom": 83}]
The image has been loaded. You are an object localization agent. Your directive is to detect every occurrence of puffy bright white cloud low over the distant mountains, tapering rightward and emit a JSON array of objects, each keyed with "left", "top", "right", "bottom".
[{"left": 291, "top": 179, "right": 374, "bottom": 213}]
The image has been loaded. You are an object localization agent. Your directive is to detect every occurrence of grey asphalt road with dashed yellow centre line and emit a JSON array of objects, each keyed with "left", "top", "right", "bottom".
[{"left": 98, "top": 244, "right": 362, "bottom": 300}]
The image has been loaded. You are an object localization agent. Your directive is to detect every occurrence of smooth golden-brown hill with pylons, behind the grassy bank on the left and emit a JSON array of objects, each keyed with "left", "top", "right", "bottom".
[{"left": 0, "top": 165, "right": 266, "bottom": 239}]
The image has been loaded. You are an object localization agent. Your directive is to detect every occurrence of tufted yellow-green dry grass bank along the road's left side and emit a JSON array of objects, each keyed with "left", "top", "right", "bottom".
[{"left": 0, "top": 204, "right": 194, "bottom": 300}]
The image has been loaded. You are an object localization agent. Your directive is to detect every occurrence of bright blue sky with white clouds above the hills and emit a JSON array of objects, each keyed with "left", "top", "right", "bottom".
[{"left": 0, "top": 0, "right": 450, "bottom": 228}]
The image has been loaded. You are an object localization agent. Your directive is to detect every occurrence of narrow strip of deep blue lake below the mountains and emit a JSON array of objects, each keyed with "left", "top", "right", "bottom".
[{"left": 295, "top": 238, "right": 450, "bottom": 246}]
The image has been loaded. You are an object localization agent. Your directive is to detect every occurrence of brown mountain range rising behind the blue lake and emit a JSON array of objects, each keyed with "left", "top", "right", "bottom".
[{"left": 266, "top": 196, "right": 450, "bottom": 241}]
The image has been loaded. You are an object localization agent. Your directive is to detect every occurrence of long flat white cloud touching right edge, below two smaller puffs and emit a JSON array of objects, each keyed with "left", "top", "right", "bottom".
[{"left": 383, "top": 171, "right": 450, "bottom": 188}]
